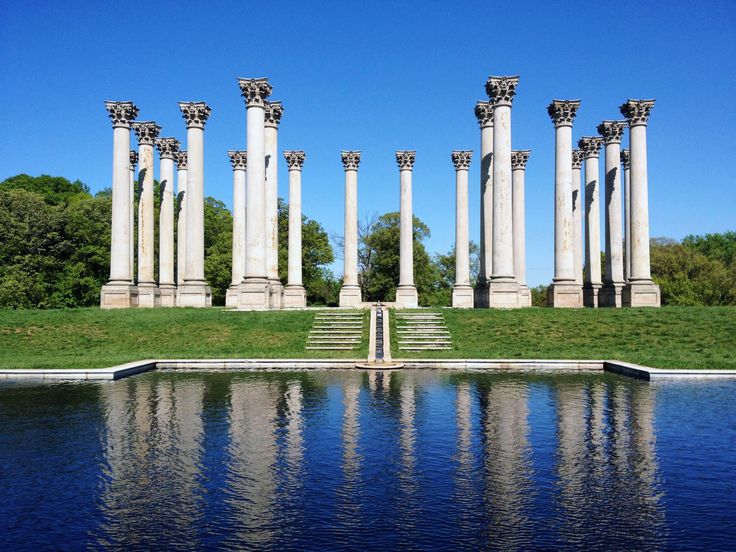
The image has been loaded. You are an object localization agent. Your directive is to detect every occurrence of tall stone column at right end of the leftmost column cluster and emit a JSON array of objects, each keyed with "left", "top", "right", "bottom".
[{"left": 177, "top": 102, "right": 212, "bottom": 307}]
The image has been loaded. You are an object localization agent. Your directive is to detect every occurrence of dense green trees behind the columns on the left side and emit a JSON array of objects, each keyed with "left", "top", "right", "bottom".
[{"left": 0, "top": 174, "right": 339, "bottom": 308}]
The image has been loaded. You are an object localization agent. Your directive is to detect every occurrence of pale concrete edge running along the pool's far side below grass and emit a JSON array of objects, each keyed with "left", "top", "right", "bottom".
[{"left": 0, "top": 358, "right": 736, "bottom": 381}]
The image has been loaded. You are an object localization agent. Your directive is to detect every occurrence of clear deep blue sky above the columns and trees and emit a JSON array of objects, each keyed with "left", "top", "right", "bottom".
[{"left": 0, "top": 0, "right": 736, "bottom": 285}]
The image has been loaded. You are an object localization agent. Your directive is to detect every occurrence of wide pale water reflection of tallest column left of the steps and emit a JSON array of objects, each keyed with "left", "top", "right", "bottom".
[{"left": 226, "top": 378, "right": 277, "bottom": 548}]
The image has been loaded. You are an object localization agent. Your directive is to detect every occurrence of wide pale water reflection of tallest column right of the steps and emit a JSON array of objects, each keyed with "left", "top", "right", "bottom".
[{"left": 484, "top": 383, "right": 532, "bottom": 542}]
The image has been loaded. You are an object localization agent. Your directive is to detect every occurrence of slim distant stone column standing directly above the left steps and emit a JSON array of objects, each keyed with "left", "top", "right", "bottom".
[{"left": 340, "top": 151, "right": 362, "bottom": 307}]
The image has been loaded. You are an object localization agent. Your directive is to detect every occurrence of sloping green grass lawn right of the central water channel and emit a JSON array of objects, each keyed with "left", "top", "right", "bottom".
[{"left": 391, "top": 307, "right": 736, "bottom": 369}]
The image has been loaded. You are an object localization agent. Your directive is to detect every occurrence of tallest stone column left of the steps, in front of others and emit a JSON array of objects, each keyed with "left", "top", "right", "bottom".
[{"left": 238, "top": 79, "right": 272, "bottom": 310}]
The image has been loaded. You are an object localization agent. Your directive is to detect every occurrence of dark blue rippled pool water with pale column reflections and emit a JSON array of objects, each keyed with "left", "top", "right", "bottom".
[{"left": 0, "top": 371, "right": 736, "bottom": 550}]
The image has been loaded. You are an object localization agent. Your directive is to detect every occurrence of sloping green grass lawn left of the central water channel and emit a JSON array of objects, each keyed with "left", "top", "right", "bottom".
[{"left": 0, "top": 308, "right": 368, "bottom": 368}]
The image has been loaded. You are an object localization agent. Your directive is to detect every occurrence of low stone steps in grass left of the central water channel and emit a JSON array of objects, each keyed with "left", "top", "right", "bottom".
[{"left": 305, "top": 311, "right": 364, "bottom": 351}]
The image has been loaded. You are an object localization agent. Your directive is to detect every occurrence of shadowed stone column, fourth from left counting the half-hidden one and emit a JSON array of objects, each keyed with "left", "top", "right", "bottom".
[{"left": 156, "top": 138, "right": 179, "bottom": 307}]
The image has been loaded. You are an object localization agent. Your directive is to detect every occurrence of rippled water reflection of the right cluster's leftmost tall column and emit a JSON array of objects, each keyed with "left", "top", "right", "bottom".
[{"left": 556, "top": 381, "right": 588, "bottom": 533}]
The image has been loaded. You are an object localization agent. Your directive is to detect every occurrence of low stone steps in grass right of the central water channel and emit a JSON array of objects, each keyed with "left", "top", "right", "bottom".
[{"left": 394, "top": 310, "right": 452, "bottom": 351}]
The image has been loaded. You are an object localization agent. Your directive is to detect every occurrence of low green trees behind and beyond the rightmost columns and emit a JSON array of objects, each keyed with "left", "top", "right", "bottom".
[{"left": 532, "top": 231, "right": 736, "bottom": 306}]
